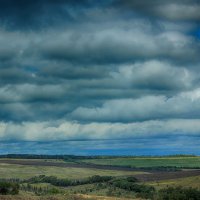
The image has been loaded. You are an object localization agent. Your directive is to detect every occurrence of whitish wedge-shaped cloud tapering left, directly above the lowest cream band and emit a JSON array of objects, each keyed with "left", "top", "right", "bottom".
[{"left": 71, "top": 89, "right": 200, "bottom": 122}]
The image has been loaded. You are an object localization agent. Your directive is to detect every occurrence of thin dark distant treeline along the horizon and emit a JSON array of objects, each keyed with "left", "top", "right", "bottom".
[{"left": 0, "top": 154, "right": 197, "bottom": 160}]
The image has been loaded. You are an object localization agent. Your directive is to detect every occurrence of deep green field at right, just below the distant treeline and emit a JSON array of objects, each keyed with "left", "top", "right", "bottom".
[{"left": 82, "top": 157, "right": 200, "bottom": 168}]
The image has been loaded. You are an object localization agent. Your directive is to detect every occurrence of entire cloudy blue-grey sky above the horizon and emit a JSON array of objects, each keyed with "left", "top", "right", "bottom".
[{"left": 0, "top": 0, "right": 200, "bottom": 155}]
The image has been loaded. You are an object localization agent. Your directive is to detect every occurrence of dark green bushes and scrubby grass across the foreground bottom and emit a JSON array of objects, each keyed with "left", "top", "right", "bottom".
[{"left": 0, "top": 176, "right": 200, "bottom": 200}]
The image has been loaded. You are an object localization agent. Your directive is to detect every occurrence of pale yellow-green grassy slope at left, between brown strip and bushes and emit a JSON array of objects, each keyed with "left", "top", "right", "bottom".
[{"left": 0, "top": 164, "right": 143, "bottom": 179}]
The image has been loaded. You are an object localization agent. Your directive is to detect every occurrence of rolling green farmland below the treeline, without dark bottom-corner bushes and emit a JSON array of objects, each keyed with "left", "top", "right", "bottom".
[{"left": 0, "top": 156, "right": 200, "bottom": 200}]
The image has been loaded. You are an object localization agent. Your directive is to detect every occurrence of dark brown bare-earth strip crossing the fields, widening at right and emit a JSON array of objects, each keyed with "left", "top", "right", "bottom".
[{"left": 0, "top": 159, "right": 200, "bottom": 182}]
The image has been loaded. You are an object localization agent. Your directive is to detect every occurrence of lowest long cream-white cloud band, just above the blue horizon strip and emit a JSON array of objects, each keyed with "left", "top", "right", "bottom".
[{"left": 0, "top": 119, "right": 200, "bottom": 141}]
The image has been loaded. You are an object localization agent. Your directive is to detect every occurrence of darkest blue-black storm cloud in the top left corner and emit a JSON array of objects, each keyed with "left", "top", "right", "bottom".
[{"left": 0, "top": 0, "right": 92, "bottom": 29}]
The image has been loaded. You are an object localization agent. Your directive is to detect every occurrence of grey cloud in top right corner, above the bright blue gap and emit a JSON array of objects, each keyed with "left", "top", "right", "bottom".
[{"left": 114, "top": 0, "right": 200, "bottom": 22}]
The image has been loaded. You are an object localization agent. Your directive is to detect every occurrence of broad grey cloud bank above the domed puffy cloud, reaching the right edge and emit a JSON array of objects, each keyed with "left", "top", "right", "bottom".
[{"left": 40, "top": 25, "right": 199, "bottom": 64}]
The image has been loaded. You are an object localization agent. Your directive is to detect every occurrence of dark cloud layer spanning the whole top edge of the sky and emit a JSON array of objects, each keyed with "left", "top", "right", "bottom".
[{"left": 0, "top": 0, "right": 200, "bottom": 30}]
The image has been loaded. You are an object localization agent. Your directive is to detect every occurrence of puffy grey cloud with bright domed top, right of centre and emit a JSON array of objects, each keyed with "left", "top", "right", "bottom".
[{"left": 111, "top": 60, "right": 196, "bottom": 90}]
